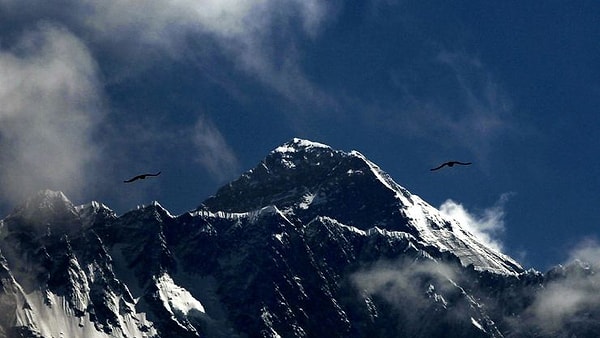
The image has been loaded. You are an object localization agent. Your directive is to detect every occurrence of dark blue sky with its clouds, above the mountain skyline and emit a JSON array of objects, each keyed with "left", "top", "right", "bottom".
[{"left": 0, "top": 0, "right": 600, "bottom": 270}]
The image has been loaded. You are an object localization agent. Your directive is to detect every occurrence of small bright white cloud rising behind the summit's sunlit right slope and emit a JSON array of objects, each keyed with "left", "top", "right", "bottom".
[{"left": 439, "top": 193, "right": 512, "bottom": 252}]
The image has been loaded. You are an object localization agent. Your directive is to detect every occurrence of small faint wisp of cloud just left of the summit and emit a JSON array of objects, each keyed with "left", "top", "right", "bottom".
[{"left": 192, "top": 117, "right": 239, "bottom": 181}]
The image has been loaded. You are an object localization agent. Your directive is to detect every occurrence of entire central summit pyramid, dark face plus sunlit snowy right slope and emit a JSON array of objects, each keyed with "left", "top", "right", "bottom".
[{"left": 199, "top": 139, "right": 522, "bottom": 274}]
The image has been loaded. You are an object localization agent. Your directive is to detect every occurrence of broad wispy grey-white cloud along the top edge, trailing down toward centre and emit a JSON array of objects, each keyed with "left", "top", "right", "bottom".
[{"left": 0, "top": 0, "right": 332, "bottom": 102}]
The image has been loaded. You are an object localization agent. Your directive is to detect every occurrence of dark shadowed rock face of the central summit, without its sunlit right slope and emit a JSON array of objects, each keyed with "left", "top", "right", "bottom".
[{"left": 199, "top": 138, "right": 411, "bottom": 218}]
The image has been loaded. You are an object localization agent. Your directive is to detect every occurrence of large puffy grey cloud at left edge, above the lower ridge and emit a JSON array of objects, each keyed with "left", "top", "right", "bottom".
[{"left": 0, "top": 24, "right": 103, "bottom": 203}]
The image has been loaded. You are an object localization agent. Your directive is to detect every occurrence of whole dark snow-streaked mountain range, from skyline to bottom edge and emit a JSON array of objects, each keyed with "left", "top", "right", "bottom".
[{"left": 0, "top": 139, "right": 599, "bottom": 337}]
